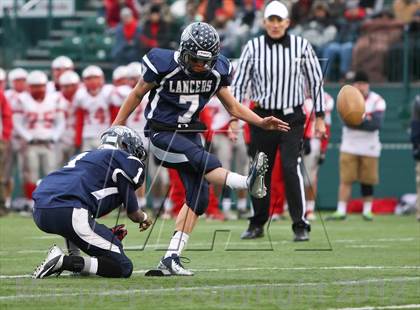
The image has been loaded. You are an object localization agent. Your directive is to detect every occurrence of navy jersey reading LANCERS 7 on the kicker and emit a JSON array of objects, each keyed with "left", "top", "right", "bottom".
[{"left": 142, "top": 48, "right": 232, "bottom": 125}]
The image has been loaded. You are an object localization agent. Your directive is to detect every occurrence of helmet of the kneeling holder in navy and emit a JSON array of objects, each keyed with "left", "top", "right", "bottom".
[{"left": 100, "top": 126, "right": 147, "bottom": 161}]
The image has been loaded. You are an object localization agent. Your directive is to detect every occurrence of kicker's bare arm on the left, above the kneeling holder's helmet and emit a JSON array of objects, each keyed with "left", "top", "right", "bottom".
[{"left": 112, "top": 77, "right": 155, "bottom": 126}]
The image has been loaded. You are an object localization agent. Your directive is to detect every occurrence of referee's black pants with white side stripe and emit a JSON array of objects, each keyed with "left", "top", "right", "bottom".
[{"left": 250, "top": 107, "right": 306, "bottom": 227}]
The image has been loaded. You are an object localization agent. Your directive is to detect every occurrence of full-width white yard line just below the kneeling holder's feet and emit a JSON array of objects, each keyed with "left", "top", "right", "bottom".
[{"left": 0, "top": 277, "right": 420, "bottom": 301}]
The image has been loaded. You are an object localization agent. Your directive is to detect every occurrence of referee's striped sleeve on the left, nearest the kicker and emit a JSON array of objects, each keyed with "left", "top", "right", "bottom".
[{"left": 232, "top": 42, "right": 253, "bottom": 102}]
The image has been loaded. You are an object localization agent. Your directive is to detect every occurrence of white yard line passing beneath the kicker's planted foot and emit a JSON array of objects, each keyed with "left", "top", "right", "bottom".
[{"left": 0, "top": 266, "right": 420, "bottom": 279}]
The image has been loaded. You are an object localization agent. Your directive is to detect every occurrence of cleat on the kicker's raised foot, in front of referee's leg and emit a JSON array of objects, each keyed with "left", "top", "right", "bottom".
[{"left": 247, "top": 152, "right": 268, "bottom": 199}]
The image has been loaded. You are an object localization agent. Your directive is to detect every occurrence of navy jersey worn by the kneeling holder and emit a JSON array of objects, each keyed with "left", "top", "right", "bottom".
[{"left": 32, "top": 149, "right": 144, "bottom": 217}]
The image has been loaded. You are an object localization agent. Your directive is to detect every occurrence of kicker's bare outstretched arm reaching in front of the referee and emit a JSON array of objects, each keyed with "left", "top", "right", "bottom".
[{"left": 217, "top": 87, "right": 290, "bottom": 131}]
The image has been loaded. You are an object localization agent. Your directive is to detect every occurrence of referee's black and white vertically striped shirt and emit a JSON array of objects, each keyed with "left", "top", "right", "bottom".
[{"left": 232, "top": 34, "right": 324, "bottom": 115}]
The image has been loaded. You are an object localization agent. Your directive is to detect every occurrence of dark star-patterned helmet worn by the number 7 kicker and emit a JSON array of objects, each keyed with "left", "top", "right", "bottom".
[{"left": 178, "top": 22, "right": 220, "bottom": 76}]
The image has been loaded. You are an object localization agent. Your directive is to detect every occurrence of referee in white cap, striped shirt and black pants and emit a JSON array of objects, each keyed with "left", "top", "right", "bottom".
[{"left": 231, "top": 1, "right": 325, "bottom": 241}]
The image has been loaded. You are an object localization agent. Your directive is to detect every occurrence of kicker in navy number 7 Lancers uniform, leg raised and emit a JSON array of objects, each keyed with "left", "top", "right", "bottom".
[{"left": 114, "top": 22, "right": 289, "bottom": 276}]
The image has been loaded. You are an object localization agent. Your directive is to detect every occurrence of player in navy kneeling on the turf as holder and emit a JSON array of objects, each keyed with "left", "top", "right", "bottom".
[{"left": 33, "top": 126, "right": 152, "bottom": 278}]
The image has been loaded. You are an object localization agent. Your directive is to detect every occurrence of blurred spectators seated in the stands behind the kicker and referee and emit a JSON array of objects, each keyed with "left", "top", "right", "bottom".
[{"left": 103, "top": 0, "right": 420, "bottom": 82}]
